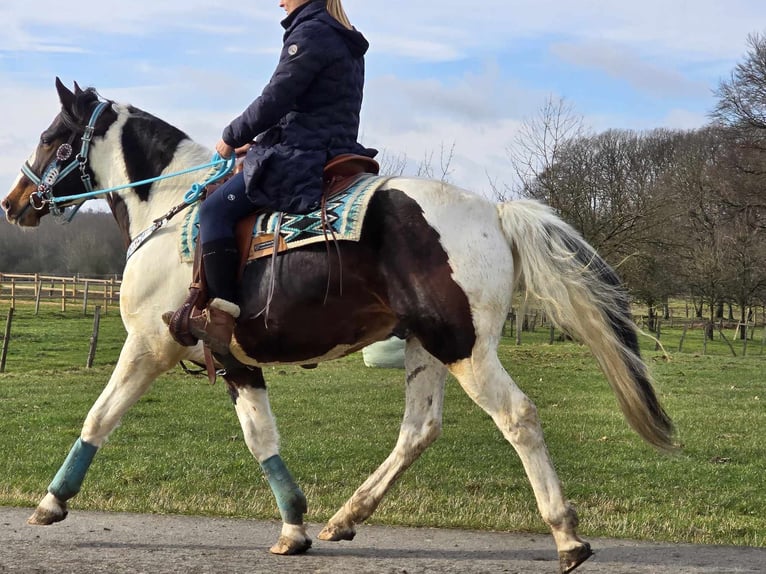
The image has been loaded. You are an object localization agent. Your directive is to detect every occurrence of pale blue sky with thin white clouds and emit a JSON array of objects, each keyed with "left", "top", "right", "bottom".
[{"left": 0, "top": 0, "right": 766, "bottom": 201}]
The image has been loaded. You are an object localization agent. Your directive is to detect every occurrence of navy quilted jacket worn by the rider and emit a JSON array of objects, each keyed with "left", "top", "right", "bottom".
[{"left": 222, "top": 0, "right": 376, "bottom": 213}]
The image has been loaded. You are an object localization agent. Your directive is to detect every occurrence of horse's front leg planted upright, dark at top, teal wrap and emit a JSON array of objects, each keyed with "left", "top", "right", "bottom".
[{"left": 224, "top": 368, "right": 311, "bottom": 554}]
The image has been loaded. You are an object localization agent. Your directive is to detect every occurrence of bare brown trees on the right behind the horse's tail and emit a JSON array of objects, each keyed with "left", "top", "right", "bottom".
[{"left": 504, "top": 35, "right": 766, "bottom": 336}]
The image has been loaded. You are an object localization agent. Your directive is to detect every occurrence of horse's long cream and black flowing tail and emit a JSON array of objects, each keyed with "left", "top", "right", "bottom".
[{"left": 498, "top": 201, "right": 673, "bottom": 450}]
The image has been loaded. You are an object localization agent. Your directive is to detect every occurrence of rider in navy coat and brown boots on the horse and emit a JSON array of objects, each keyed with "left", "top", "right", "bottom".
[{"left": 175, "top": 0, "right": 377, "bottom": 354}]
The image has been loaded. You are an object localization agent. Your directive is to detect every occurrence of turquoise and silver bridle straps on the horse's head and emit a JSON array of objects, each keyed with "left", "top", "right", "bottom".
[{"left": 21, "top": 102, "right": 109, "bottom": 216}]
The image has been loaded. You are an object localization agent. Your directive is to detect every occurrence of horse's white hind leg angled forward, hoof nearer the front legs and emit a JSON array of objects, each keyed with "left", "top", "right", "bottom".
[{"left": 319, "top": 339, "right": 447, "bottom": 540}]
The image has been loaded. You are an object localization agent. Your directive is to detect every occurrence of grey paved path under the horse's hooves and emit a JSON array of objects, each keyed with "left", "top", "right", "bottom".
[{"left": 0, "top": 508, "right": 766, "bottom": 574}]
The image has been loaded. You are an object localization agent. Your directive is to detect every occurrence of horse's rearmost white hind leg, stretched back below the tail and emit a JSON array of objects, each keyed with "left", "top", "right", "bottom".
[{"left": 450, "top": 341, "right": 591, "bottom": 573}]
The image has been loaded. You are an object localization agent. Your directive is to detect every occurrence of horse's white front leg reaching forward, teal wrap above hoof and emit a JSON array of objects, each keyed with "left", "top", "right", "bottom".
[{"left": 28, "top": 335, "right": 180, "bottom": 525}]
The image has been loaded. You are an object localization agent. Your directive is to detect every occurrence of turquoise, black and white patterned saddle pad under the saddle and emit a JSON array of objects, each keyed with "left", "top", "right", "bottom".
[{"left": 180, "top": 175, "right": 390, "bottom": 261}]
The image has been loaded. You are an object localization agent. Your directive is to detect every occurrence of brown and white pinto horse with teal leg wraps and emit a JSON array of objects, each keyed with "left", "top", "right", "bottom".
[{"left": 2, "top": 78, "right": 673, "bottom": 572}]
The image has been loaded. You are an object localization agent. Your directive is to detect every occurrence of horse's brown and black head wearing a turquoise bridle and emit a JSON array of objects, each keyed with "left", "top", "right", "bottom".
[{"left": 0, "top": 78, "right": 115, "bottom": 227}]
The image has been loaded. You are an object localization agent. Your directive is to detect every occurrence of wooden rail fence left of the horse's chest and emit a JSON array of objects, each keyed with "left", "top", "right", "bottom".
[{"left": 0, "top": 273, "right": 121, "bottom": 315}]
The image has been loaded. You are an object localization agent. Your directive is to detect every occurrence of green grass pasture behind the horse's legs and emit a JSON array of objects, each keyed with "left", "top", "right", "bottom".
[{"left": 0, "top": 304, "right": 766, "bottom": 546}]
